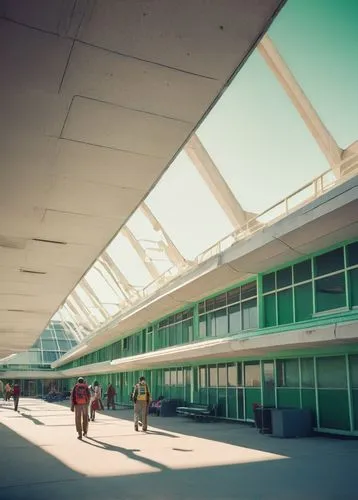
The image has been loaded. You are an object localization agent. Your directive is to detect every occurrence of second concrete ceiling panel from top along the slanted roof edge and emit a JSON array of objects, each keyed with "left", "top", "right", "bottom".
[{"left": 62, "top": 43, "right": 221, "bottom": 123}]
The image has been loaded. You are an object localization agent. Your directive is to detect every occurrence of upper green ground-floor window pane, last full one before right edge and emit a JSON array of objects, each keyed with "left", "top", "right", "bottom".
[{"left": 316, "top": 356, "right": 347, "bottom": 389}]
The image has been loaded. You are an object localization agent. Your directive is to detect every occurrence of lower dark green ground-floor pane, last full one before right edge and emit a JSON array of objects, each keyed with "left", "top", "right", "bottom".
[{"left": 318, "top": 389, "right": 350, "bottom": 431}]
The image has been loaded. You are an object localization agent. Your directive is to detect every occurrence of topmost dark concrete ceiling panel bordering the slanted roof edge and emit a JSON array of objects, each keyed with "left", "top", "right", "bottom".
[{"left": 79, "top": 0, "right": 280, "bottom": 81}]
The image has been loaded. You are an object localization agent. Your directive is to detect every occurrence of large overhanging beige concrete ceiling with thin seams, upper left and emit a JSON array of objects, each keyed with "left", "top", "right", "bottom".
[{"left": 0, "top": 0, "right": 284, "bottom": 356}]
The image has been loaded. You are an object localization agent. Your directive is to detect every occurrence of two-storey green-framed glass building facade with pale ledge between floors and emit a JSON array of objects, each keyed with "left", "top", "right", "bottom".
[{"left": 58, "top": 240, "right": 358, "bottom": 435}]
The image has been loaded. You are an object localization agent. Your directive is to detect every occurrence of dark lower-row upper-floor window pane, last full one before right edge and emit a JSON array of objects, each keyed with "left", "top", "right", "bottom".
[{"left": 315, "top": 273, "right": 347, "bottom": 312}]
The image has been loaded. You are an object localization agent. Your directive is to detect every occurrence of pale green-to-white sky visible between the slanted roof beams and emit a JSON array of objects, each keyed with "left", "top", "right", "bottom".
[{"left": 53, "top": 0, "right": 358, "bottom": 330}]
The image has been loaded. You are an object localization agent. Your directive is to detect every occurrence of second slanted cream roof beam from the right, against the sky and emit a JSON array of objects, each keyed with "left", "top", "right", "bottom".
[{"left": 184, "top": 134, "right": 252, "bottom": 229}]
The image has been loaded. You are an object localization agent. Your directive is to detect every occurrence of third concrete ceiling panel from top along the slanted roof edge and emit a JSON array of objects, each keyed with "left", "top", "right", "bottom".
[{"left": 62, "top": 96, "right": 193, "bottom": 155}]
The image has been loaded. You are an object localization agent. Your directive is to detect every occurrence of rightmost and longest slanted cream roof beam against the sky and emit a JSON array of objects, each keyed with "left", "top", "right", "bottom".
[{"left": 257, "top": 35, "right": 342, "bottom": 178}]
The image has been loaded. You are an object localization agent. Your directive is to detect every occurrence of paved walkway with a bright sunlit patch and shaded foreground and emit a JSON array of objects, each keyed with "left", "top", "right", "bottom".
[{"left": 0, "top": 399, "right": 358, "bottom": 500}]
